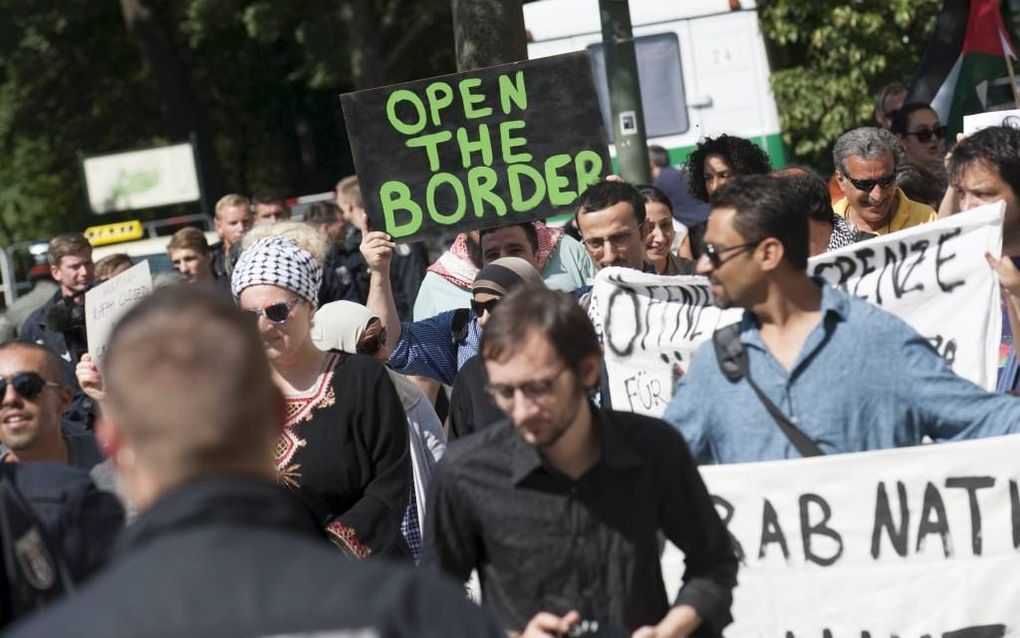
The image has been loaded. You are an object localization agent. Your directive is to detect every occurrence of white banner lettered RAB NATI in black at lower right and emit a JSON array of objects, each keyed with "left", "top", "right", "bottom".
[{"left": 662, "top": 435, "right": 1020, "bottom": 638}]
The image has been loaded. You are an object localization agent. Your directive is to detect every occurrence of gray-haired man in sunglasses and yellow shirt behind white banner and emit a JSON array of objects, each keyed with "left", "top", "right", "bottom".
[{"left": 832, "top": 127, "right": 937, "bottom": 240}]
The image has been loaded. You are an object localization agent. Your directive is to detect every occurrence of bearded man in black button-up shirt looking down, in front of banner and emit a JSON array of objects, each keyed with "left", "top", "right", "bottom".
[{"left": 424, "top": 287, "right": 736, "bottom": 637}]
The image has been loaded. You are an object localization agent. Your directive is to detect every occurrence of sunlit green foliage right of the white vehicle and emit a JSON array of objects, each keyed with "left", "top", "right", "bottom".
[{"left": 759, "top": 0, "right": 942, "bottom": 168}]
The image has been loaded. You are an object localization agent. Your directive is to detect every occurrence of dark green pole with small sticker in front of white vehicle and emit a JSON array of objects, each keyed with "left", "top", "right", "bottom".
[{"left": 599, "top": 0, "right": 652, "bottom": 184}]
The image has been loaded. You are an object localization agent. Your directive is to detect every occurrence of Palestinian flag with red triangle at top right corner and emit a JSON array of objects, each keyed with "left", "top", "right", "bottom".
[{"left": 907, "top": 0, "right": 1017, "bottom": 140}]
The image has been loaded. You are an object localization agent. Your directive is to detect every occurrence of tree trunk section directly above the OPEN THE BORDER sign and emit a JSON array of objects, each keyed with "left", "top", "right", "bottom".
[{"left": 451, "top": 0, "right": 527, "bottom": 71}]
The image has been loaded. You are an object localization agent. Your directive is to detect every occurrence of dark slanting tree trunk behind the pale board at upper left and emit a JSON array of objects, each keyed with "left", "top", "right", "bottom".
[{"left": 120, "top": 0, "right": 222, "bottom": 201}]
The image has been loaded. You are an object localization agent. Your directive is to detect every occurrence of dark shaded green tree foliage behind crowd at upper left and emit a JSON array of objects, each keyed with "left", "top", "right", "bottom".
[{"left": 0, "top": 0, "right": 455, "bottom": 247}]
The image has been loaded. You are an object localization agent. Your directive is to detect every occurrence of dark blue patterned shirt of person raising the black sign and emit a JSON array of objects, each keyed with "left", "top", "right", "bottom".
[{"left": 387, "top": 310, "right": 481, "bottom": 386}]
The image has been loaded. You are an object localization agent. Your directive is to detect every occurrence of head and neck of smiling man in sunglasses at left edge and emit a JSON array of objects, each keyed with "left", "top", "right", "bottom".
[{"left": 0, "top": 342, "right": 103, "bottom": 470}]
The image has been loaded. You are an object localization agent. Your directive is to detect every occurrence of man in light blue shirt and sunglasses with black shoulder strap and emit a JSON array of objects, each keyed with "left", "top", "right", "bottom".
[{"left": 664, "top": 177, "right": 1020, "bottom": 463}]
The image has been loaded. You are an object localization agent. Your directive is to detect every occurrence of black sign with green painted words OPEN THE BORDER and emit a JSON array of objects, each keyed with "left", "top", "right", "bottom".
[{"left": 341, "top": 52, "right": 610, "bottom": 241}]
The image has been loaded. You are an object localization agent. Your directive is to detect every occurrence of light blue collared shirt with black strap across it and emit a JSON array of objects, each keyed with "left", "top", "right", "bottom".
[{"left": 664, "top": 280, "right": 1020, "bottom": 463}]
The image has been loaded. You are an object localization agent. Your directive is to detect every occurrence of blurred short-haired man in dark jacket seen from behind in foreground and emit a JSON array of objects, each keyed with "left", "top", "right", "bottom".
[{"left": 12, "top": 286, "right": 499, "bottom": 638}]
